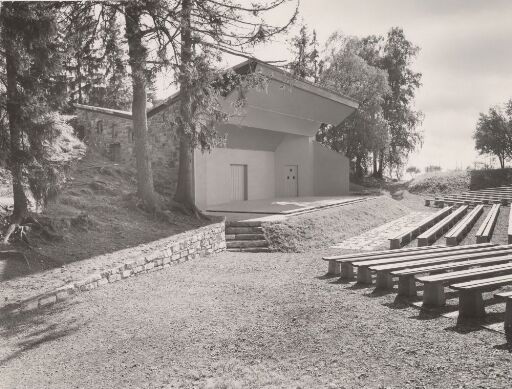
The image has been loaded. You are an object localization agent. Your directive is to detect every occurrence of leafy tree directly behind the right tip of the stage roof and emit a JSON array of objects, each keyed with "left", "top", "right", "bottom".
[{"left": 317, "top": 33, "right": 390, "bottom": 177}]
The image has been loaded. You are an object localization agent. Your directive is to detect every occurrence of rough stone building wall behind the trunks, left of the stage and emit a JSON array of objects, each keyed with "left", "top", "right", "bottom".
[{"left": 76, "top": 107, "right": 179, "bottom": 195}]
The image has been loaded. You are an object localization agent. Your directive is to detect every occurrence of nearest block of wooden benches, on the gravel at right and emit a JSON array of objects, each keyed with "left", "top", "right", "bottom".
[{"left": 323, "top": 243, "right": 512, "bottom": 325}]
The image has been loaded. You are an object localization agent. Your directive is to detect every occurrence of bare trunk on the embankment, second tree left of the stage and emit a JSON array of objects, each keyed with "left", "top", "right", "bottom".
[{"left": 125, "top": 2, "right": 158, "bottom": 210}]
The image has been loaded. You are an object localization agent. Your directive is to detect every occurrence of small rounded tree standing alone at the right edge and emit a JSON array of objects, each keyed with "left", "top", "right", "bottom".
[{"left": 473, "top": 103, "right": 512, "bottom": 169}]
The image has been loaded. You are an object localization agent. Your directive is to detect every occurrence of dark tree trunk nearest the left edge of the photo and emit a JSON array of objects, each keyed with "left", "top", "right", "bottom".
[{"left": 2, "top": 5, "right": 28, "bottom": 224}]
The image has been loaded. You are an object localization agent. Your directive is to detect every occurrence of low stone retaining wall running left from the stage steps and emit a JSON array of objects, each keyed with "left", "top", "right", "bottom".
[{"left": 7, "top": 221, "right": 226, "bottom": 312}]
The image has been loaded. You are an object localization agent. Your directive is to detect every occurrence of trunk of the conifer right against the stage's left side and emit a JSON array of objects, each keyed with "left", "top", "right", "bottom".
[{"left": 174, "top": 0, "right": 196, "bottom": 210}]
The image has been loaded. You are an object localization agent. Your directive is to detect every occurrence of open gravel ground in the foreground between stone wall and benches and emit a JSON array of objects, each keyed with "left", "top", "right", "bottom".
[{"left": 0, "top": 249, "right": 512, "bottom": 389}]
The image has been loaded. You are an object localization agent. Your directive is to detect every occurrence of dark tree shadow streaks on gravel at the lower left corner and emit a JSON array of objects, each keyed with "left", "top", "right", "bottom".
[{"left": 0, "top": 302, "right": 87, "bottom": 366}]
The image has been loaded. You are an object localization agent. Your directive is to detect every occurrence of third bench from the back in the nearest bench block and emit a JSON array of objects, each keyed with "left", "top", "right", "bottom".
[{"left": 351, "top": 245, "right": 498, "bottom": 284}]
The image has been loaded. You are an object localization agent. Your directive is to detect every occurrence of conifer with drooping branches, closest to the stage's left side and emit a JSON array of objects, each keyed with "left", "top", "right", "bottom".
[{"left": 173, "top": 0, "right": 297, "bottom": 215}]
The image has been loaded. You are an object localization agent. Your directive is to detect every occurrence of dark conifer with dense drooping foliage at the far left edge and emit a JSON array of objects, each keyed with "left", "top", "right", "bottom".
[{"left": 0, "top": 2, "right": 65, "bottom": 230}]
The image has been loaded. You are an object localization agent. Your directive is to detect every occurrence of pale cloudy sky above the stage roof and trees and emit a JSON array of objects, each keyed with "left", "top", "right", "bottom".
[{"left": 158, "top": 0, "right": 512, "bottom": 169}]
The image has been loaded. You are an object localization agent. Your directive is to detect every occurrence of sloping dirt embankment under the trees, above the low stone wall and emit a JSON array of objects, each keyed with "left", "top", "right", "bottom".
[{"left": 0, "top": 151, "right": 208, "bottom": 280}]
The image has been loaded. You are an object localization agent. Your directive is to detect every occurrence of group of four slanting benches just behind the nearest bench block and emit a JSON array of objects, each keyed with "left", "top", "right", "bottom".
[{"left": 389, "top": 204, "right": 500, "bottom": 249}]
